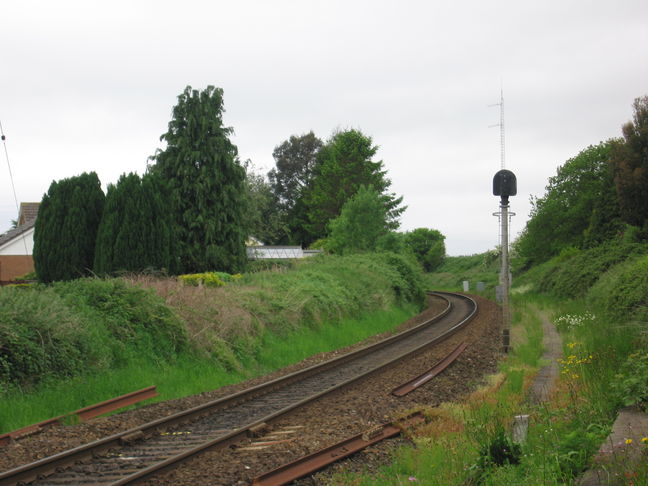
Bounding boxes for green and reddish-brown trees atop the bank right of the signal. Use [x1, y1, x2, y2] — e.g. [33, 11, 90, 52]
[513, 96, 648, 269]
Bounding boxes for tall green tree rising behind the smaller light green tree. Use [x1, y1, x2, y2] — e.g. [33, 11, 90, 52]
[304, 129, 406, 239]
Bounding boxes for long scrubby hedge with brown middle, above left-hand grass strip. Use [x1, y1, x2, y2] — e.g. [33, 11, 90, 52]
[0, 253, 425, 385]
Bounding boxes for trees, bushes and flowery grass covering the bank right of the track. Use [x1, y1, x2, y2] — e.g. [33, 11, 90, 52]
[340, 97, 648, 486]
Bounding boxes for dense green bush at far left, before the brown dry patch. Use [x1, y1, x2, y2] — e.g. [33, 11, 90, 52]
[0, 279, 187, 385]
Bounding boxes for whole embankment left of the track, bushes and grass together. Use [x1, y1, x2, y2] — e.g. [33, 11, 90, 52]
[0, 255, 423, 433]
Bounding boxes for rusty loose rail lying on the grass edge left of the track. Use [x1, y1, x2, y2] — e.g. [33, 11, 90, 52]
[0, 385, 157, 446]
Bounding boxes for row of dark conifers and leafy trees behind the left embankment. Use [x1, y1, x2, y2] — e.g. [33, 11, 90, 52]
[34, 86, 445, 282]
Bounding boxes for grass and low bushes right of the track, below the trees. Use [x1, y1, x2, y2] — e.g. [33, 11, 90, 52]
[334, 242, 648, 486]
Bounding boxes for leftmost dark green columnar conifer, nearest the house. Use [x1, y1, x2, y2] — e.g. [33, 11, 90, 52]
[34, 172, 105, 282]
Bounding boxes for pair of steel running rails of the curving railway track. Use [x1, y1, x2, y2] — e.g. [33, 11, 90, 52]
[0, 293, 476, 486]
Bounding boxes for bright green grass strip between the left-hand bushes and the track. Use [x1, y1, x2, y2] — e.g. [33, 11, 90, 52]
[0, 305, 418, 433]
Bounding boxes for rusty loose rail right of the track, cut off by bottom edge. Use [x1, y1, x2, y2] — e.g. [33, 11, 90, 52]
[252, 412, 425, 486]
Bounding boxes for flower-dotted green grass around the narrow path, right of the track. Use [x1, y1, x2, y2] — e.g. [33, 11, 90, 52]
[332, 294, 648, 486]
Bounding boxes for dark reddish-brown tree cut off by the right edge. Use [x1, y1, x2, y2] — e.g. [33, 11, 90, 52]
[611, 96, 648, 230]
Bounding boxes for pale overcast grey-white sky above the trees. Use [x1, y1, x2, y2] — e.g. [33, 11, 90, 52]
[0, 0, 648, 255]
